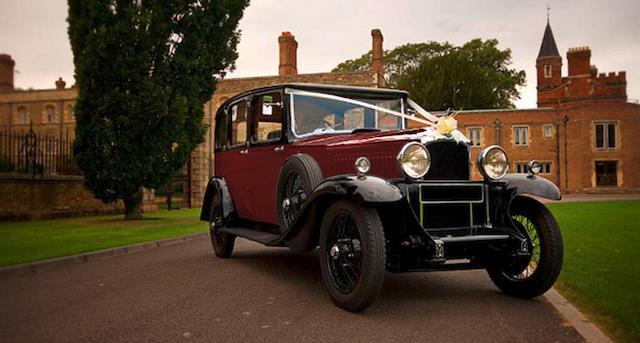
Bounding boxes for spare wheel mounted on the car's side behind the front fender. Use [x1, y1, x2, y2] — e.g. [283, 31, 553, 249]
[276, 154, 322, 230]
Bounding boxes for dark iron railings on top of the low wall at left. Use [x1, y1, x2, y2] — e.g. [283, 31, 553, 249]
[0, 127, 81, 177]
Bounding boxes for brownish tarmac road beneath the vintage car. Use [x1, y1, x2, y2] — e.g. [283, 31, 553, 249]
[0, 239, 583, 342]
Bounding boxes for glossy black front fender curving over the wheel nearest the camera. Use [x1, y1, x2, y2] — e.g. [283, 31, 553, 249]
[273, 175, 403, 252]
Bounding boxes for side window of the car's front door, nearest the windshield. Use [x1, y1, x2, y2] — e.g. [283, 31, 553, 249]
[251, 92, 283, 143]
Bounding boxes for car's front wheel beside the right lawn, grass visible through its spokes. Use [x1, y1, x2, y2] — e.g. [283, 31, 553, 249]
[487, 196, 564, 299]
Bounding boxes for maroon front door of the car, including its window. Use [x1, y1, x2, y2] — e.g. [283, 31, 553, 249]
[249, 91, 289, 225]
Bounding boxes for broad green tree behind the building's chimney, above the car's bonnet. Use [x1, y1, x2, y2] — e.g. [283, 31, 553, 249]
[334, 39, 526, 110]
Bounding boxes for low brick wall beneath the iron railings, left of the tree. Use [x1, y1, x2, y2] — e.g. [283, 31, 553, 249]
[0, 174, 124, 221]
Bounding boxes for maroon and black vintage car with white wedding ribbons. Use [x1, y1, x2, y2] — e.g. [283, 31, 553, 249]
[200, 84, 563, 311]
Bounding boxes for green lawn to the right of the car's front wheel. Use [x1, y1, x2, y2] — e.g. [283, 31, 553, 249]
[549, 201, 640, 342]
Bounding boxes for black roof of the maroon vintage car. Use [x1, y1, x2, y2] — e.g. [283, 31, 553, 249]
[220, 83, 409, 108]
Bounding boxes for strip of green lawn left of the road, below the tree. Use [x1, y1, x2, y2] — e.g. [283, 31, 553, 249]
[0, 209, 207, 266]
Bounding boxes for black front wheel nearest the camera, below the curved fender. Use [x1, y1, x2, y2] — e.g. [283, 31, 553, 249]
[319, 200, 386, 312]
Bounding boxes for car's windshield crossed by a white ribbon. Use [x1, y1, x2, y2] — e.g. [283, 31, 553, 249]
[291, 93, 405, 137]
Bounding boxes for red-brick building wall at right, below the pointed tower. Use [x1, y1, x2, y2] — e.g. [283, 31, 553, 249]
[457, 102, 640, 192]
